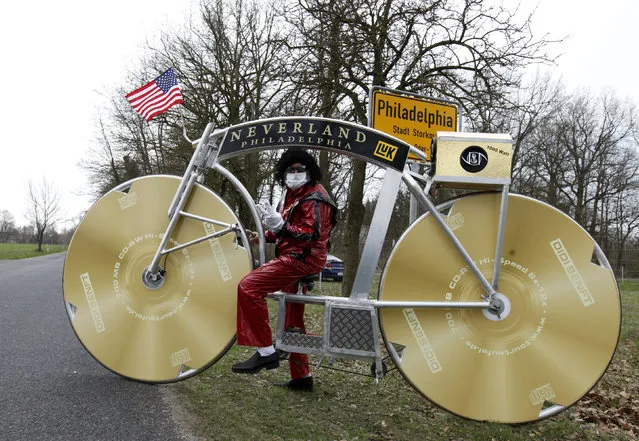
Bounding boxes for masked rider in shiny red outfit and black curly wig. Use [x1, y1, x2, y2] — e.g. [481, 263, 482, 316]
[232, 149, 337, 391]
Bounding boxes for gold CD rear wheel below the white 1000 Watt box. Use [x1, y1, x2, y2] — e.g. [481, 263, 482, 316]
[379, 193, 621, 423]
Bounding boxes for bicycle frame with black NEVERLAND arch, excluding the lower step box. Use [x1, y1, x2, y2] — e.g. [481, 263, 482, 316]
[145, 117, 508, 309]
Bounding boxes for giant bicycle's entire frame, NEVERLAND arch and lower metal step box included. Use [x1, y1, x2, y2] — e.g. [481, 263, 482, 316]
[107, 117, 584, 418]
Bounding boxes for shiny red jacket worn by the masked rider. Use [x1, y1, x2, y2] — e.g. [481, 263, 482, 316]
[266, 184, 337, 272]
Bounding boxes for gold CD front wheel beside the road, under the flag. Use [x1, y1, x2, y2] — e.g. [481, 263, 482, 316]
[63, 176, 251, 382]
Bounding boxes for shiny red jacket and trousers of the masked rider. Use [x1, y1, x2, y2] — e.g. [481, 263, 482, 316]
[237, 184, 334, 378]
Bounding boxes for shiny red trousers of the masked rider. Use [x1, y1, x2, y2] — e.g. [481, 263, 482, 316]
[237, 255, 322, 379]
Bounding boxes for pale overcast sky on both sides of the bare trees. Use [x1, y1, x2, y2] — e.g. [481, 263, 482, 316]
[0, 0, 639, 226]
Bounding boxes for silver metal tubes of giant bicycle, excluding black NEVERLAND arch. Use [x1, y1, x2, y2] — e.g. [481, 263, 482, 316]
[148, 118, 508, 320]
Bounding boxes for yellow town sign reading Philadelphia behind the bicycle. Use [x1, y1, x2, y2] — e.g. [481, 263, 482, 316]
[371, 90, 458, 161]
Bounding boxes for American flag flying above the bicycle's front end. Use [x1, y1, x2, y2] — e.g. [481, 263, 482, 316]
[126, 67, 182, 121]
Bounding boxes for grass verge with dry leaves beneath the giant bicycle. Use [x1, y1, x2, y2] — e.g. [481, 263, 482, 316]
[171, 282, 639, 441]
